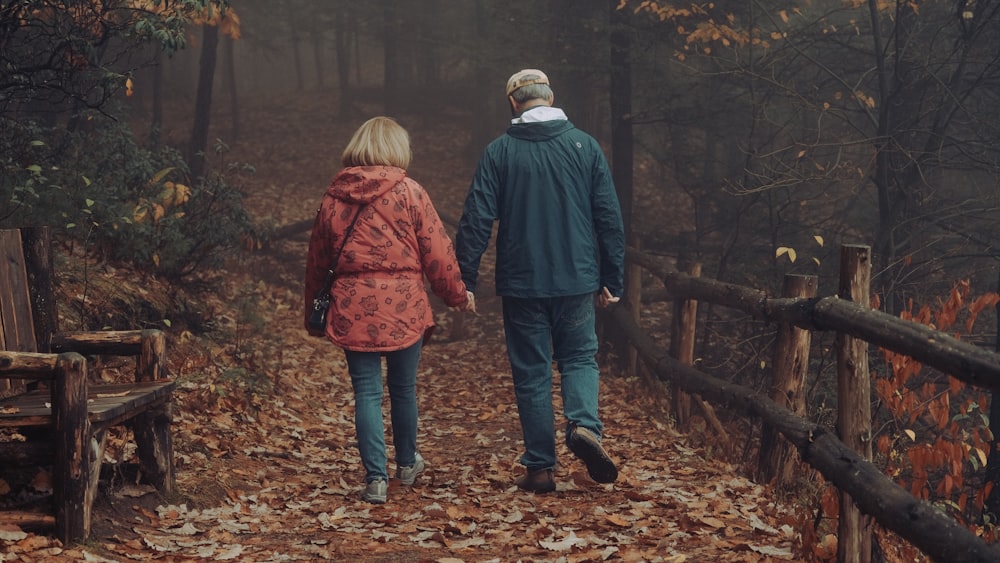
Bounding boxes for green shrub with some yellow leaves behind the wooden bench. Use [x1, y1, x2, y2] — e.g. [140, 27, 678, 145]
[0, 112, 254, 280]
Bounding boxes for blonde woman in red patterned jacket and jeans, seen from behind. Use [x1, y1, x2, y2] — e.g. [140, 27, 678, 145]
[305, 117, 475, 503]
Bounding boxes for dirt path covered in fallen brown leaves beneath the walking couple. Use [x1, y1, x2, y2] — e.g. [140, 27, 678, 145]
[102, 278, 795, 561]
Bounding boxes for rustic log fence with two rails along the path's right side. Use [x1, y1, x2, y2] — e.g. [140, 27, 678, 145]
[609, 245, 1000, 563]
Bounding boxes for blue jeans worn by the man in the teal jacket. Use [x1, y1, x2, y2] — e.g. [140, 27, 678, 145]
[503, 293, 603, 471]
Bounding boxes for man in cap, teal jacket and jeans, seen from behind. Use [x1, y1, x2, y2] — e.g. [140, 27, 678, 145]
[455, 69, 625, 492]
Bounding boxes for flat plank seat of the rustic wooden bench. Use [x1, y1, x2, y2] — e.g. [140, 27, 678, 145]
[0, 381, 177, 427]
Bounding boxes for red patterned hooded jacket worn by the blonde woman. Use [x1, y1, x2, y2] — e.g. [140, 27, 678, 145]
[305, 166, 466, 352]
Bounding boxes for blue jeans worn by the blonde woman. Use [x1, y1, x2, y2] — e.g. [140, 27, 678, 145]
[344, 342, 422, 482]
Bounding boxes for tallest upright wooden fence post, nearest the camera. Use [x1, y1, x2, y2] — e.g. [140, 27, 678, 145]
[836, 245, 872, 563]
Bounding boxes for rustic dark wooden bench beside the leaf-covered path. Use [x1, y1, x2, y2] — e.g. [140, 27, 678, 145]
[0, 227, 175, 543]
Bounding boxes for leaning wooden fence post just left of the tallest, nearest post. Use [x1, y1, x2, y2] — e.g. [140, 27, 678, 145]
[757, 274, 817, 485]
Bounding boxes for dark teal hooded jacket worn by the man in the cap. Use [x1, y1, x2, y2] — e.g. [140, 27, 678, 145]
[455, 120, 625, 298]
